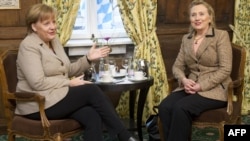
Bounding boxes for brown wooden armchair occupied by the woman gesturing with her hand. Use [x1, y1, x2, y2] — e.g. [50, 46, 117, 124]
[0, 48, 83, 141]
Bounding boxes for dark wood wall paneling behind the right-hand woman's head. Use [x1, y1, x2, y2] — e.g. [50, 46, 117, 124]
[157, 0, 234, 24]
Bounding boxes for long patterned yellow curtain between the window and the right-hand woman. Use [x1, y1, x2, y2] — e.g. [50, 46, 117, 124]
[116, 0, 168, 121]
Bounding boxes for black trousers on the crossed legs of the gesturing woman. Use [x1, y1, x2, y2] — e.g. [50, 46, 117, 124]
[26, 84, 126, 141]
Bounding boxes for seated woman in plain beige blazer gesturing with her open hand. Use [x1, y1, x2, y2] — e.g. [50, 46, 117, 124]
[15, 4, 135, 141]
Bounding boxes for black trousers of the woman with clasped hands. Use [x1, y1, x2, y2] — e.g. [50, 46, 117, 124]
[159, 90, 227, 141]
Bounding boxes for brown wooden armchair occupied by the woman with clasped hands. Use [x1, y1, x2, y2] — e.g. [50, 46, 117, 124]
[158, 44, 246, 141]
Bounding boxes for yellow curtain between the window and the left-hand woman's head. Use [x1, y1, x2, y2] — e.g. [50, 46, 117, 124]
[42, 0, 81, 46]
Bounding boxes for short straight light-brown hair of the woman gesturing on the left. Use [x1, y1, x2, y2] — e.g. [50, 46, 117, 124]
[26, 3, 56, 33]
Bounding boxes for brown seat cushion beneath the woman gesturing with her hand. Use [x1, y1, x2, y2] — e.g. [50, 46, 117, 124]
[12, 116, 82, 135]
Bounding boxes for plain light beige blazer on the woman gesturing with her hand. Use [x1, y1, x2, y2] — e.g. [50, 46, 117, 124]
[15, 33, 90, 115]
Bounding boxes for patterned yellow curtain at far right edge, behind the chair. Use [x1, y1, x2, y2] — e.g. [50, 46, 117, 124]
[231, 0, 250, 115]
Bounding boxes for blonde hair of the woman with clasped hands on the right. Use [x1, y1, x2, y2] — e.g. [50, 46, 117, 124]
[188, 0, 216, 32]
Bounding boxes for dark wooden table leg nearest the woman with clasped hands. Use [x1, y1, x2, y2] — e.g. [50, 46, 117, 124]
[137, 87, 149, 141]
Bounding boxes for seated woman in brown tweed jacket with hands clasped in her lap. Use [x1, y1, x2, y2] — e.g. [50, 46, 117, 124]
[159, 0, 232, 141]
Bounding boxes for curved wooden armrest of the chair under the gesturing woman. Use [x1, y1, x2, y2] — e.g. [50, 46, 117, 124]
[14, 92, 50, 128]
